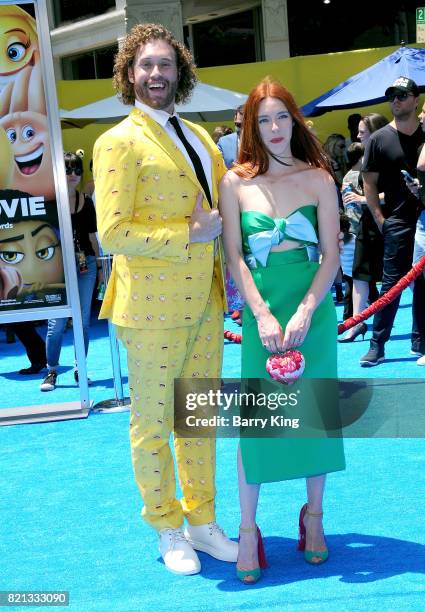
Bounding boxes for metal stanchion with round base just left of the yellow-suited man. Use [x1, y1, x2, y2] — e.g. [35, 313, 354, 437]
[92, 254, 130, 412]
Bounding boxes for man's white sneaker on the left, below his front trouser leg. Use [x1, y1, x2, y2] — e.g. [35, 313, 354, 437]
[159, 529, 201, 576]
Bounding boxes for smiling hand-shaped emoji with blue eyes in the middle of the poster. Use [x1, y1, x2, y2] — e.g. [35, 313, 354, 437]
[0, 111, 55, 200]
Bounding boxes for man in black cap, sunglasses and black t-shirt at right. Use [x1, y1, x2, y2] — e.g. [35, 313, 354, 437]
[360, 76, 425, 367]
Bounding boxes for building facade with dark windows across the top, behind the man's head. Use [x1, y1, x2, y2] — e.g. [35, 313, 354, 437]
[47, 0, 416, 80]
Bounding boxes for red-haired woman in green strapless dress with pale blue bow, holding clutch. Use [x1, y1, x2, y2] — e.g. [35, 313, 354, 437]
[220, 79, 345, 584]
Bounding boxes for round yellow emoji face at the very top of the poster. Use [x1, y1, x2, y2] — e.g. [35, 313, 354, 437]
[0, 5, 38, 93]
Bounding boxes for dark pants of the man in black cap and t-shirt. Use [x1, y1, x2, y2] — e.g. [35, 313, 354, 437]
[371, 220, 425, 346]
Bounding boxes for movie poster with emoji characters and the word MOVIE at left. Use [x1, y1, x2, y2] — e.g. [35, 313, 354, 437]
[0, 3, 66, 311]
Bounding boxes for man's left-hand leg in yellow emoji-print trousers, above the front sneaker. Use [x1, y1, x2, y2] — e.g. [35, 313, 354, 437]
[117, 327, 190, 531]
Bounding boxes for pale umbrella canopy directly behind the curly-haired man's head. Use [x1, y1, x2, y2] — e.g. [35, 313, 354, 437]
[60, 83, 248, 125]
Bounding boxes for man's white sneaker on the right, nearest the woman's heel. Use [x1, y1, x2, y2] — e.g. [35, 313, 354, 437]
[184, 522, 238, 563]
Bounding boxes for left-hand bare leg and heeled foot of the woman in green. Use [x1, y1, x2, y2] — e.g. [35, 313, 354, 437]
[237, 447, 260, 582]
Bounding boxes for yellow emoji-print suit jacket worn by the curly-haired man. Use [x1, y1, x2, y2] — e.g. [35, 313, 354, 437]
[93, 109, 226, 329]
